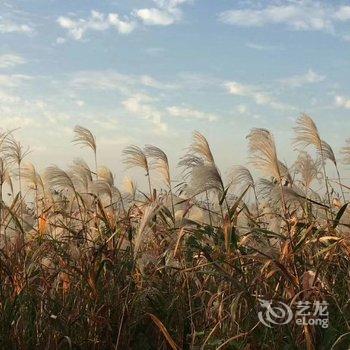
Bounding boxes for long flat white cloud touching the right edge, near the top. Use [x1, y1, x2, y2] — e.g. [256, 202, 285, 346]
[219, 0, 350, 31]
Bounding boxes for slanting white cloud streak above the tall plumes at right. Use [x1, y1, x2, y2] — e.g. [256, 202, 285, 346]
[224, 81, 293, 110]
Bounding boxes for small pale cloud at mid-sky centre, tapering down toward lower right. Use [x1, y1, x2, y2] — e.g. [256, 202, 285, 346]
[122, 94, 168, 134]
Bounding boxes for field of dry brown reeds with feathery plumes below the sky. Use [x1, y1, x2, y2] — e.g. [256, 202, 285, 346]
[0, 114, 350, 350]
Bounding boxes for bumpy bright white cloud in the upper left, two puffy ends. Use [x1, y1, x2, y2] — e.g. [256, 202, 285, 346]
[57, 11, 135, 40]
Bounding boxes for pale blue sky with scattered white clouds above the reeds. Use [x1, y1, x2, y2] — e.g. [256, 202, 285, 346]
[0, 0, 350, 180]
